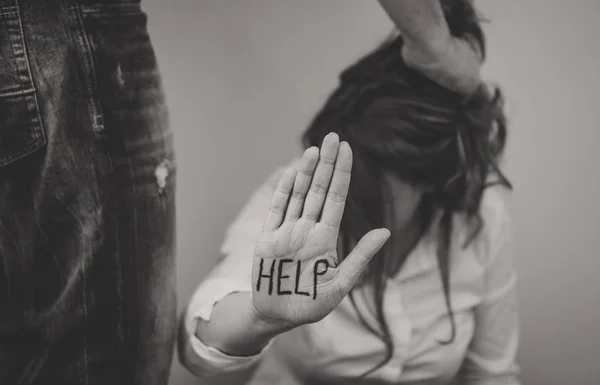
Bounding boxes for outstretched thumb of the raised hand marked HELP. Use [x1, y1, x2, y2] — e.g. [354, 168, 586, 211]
[338, 229, 390, 294]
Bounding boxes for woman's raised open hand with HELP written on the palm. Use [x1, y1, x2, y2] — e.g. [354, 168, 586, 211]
[252, 134, 389, 327]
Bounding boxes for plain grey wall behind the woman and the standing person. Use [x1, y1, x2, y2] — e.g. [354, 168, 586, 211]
[143, 0, 600, 385]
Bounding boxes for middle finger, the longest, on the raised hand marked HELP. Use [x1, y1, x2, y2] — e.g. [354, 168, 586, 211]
[302, 133, 340, 221]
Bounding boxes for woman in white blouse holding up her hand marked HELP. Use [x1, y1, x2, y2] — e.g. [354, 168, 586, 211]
[180, 1, 520, 385]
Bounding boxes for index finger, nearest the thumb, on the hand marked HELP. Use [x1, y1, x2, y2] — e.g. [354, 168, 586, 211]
[321, 142, 352, 228]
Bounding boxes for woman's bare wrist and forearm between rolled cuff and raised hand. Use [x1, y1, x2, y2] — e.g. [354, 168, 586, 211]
[196, 293, 285, 356]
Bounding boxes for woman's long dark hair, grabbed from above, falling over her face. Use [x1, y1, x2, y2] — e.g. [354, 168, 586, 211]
[303, 0, 511, 375]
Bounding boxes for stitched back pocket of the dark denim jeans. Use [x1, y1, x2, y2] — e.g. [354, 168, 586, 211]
[0, 6, 47, 167]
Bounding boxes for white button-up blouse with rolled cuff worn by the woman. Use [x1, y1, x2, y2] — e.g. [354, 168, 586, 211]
[180, 160, 520, 385]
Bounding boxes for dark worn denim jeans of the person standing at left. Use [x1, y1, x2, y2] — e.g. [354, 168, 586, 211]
[0, 0, 176, 385]
